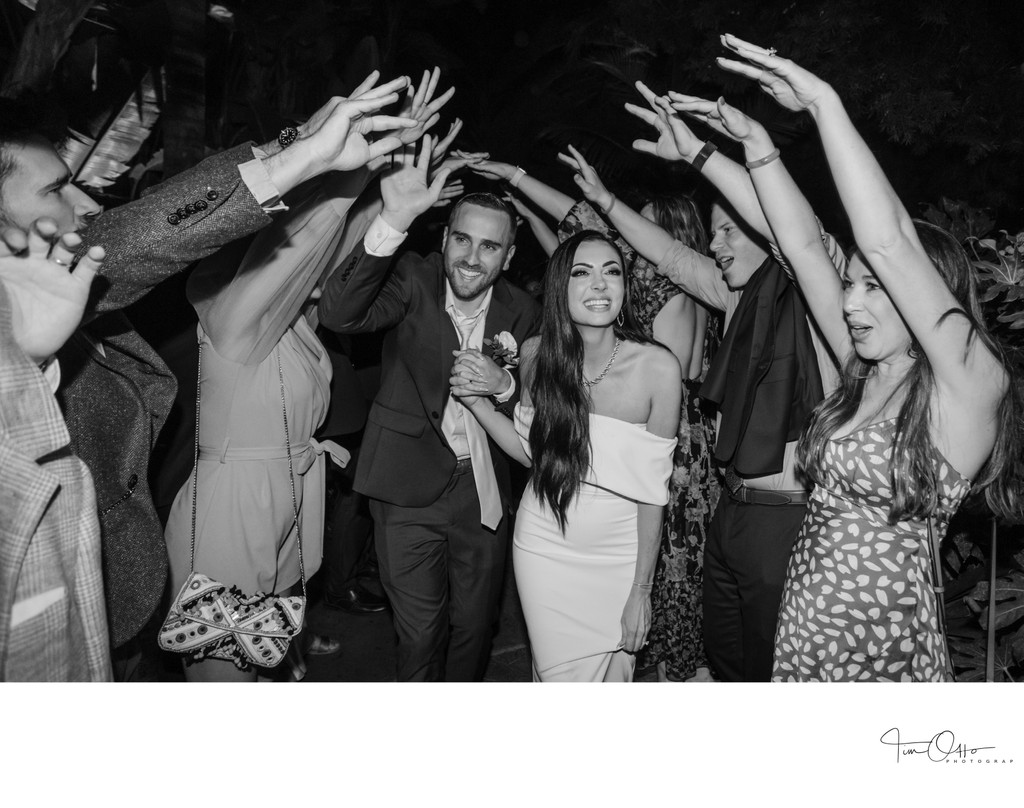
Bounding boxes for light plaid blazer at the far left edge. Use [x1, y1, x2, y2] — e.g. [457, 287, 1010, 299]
[0, 282, 111, 682]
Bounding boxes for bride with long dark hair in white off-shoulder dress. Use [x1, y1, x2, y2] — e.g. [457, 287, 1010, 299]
[452, 231, 681, 681]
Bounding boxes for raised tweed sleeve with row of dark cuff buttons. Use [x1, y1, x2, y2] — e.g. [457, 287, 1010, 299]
[79, 144, 270, 318]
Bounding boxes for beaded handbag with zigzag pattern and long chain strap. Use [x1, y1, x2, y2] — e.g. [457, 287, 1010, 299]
[160, 340, 306, 671]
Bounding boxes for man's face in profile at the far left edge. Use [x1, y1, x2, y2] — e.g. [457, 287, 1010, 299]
[0, 138, 102, 235]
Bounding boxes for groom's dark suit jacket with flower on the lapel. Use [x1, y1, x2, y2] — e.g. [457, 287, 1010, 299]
[318, 246, 541, 507]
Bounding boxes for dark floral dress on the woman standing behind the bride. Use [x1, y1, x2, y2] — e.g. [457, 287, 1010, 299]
[558, 201, 721, 679]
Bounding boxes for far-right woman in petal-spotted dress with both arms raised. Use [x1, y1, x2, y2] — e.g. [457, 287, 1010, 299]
[667, 35, 1024, 681]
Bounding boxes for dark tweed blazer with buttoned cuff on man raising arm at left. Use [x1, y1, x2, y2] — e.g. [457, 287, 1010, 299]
[57, 144, 270, 647]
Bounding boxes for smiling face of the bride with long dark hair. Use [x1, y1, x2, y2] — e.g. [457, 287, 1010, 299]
[567, 241, 626, 328]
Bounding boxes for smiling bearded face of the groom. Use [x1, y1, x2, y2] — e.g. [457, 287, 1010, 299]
[443, 205, 515, 303]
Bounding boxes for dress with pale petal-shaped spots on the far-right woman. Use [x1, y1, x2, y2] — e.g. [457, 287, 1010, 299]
[772, 419, 971, 682]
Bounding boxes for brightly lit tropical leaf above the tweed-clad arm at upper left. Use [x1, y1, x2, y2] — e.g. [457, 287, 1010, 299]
[62, 72, 160, 188]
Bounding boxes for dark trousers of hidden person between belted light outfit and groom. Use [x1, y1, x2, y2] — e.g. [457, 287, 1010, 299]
[319, 432, 374, 596]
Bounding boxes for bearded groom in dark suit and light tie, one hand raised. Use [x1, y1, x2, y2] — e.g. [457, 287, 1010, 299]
[318, 138, 540, 681]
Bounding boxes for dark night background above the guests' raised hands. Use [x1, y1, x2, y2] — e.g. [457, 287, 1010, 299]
[0, 0, 1024, 261]
